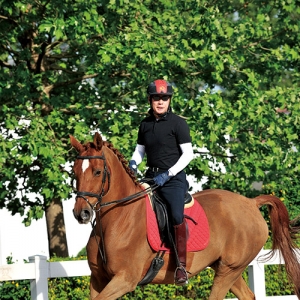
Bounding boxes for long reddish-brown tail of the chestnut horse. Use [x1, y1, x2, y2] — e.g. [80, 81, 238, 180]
[255, 195, 300, 299]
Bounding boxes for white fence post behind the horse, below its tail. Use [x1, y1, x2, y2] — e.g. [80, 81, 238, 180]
[248, 260, 267, 300]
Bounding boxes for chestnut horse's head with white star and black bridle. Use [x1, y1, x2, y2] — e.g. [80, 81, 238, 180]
[70, 133, 110, 224]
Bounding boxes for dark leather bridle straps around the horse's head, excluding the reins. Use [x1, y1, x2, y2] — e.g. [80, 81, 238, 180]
[76, 153, 110, 211]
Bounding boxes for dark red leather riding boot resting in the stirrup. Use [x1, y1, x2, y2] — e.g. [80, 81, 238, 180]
[174, 221, 188, 285]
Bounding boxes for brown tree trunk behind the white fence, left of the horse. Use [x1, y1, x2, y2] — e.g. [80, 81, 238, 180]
[45, 198, 69, 257]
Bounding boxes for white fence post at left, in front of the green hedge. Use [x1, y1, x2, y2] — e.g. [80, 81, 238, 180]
[29, 255, 49, 300]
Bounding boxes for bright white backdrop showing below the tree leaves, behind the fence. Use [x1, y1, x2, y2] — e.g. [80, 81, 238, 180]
[0, 176, 202, 265]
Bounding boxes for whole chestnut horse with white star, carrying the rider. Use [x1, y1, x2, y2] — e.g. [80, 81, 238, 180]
[70, 133, 300, 300]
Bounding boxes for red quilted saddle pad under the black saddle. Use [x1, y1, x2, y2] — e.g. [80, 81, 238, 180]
[146, 196, 209, 253]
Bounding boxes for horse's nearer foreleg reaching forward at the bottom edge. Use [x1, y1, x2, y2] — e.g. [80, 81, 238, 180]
[92, 272, 138, 300]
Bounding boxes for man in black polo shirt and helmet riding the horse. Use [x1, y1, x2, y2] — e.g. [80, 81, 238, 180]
[129, 79, 193, 285]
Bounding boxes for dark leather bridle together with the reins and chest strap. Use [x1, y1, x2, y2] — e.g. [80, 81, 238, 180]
[76, 153, 159, 264]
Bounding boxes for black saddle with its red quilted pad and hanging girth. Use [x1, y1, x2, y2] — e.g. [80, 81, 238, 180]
[139, 184, 210, 285]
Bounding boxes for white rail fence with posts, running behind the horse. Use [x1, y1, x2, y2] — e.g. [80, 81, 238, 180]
[0, 250, 297, 300]
